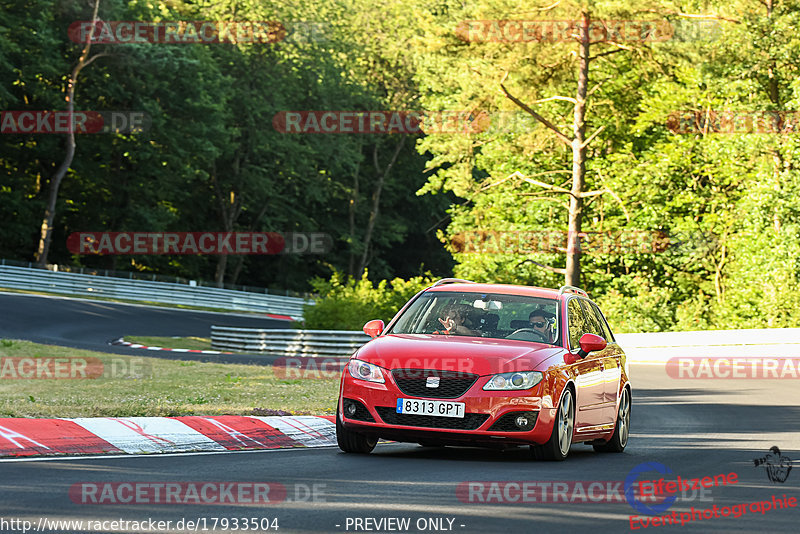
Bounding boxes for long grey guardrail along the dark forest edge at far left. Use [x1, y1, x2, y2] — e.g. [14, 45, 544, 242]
[0, 265, 313, 320]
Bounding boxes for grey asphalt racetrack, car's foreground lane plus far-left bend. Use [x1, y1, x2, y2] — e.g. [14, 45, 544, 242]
[0, 296, 800, 534]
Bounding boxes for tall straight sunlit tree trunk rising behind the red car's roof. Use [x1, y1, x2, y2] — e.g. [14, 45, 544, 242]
[564, 11, 589, 287]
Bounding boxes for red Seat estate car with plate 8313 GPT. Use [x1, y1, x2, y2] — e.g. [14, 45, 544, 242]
[336, 279, 631, 460]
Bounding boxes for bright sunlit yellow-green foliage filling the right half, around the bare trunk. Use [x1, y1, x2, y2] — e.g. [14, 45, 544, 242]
[415, 0, 800, 332]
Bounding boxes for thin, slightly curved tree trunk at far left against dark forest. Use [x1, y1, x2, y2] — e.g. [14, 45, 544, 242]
[34, 0, 107, 267]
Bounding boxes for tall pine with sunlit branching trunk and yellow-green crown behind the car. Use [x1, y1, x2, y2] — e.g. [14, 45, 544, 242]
[412, 1, 708, 285]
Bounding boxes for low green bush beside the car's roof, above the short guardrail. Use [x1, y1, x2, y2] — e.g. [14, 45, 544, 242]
[303, 272, 434, 330]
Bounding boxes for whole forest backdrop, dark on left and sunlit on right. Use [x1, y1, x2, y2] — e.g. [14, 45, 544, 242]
[0, 0, 800, 331]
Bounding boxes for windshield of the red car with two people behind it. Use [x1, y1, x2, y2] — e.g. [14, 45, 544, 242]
[389, 291, 560, 345]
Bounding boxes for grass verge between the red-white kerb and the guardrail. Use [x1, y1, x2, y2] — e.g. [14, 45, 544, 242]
[0, 338, 339, 417]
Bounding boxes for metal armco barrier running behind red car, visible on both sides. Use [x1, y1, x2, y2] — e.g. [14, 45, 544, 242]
[211, 326, 800, 363]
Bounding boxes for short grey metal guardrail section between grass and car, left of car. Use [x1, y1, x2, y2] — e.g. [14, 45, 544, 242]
[211, 326, 370, 358]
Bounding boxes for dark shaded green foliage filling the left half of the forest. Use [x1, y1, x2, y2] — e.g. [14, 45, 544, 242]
[0, 0, 452, 291]
